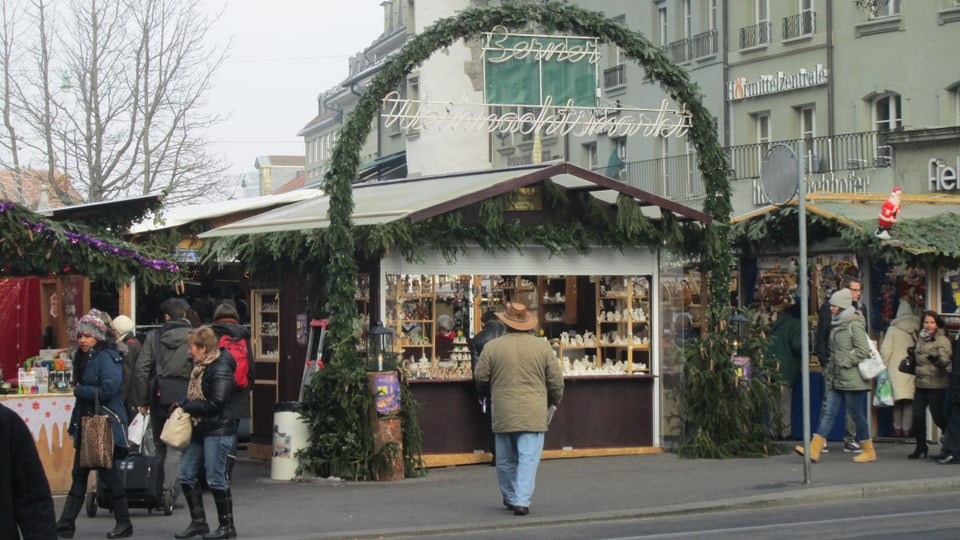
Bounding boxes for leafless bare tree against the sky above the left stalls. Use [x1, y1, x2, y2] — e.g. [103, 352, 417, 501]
[0, 0, 225, 203]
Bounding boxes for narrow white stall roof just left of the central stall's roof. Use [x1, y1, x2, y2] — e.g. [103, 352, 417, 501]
[130, 189, 323, 234]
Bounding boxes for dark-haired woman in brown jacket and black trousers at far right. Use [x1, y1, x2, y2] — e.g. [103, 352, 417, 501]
[907, 310, 952, 459]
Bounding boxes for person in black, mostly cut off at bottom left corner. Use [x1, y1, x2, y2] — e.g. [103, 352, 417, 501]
[0, 398, 57, 540]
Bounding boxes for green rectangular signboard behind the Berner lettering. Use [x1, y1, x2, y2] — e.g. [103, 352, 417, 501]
[483, 27, 600, 107]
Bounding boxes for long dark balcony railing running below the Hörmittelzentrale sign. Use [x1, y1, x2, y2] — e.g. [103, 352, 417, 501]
[594, 131, 894, 200]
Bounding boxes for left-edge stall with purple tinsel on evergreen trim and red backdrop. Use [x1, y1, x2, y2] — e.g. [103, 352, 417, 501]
[0, 197, 179, 492]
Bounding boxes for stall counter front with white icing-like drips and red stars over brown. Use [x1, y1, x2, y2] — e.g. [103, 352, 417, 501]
[0, 393, 74, 494]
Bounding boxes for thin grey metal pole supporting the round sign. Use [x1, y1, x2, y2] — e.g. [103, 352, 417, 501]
[797, 140, 810, 484]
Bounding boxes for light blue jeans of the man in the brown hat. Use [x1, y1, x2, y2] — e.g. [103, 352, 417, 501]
[494, 431, 543, 506]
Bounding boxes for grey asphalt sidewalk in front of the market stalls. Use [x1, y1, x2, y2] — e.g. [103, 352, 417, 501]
[57, 443, 960, 539]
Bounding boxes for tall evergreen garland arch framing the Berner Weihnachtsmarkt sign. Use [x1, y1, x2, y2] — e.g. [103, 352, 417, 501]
[311, 1, 742, 472]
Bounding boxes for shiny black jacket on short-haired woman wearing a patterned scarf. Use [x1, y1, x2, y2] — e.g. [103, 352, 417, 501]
[180, 351, 237, 440]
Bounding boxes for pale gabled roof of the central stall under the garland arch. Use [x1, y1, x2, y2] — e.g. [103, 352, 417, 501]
[200, 161, 710, 238]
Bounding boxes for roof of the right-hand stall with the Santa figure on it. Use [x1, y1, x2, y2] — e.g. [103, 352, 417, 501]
[732, 192, 960, 254]
